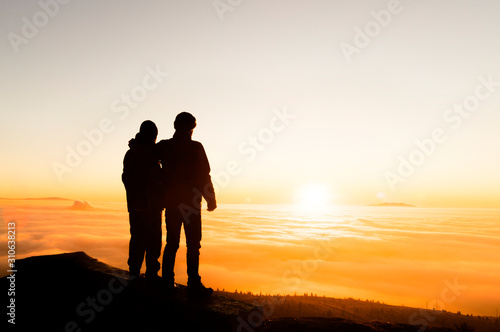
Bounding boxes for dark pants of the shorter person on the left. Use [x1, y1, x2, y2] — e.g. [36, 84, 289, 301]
[128, 210, 162, 275]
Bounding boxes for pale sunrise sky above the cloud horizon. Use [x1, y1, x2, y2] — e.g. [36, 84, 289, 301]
[0, 0, 500, 208]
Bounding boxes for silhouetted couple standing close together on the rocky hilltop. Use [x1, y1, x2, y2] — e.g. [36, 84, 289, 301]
[122, 112, 217, 297]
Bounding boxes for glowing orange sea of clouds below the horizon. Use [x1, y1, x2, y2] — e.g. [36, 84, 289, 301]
[0, 198, 500, 315]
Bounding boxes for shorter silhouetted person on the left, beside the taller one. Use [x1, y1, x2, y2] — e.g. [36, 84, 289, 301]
[122, 120, 163, 279]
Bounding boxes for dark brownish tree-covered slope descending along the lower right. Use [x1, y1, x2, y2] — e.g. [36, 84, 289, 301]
[224, 291, 500, 332]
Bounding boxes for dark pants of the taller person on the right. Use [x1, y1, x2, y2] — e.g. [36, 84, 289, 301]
[162, 202, 201, 284]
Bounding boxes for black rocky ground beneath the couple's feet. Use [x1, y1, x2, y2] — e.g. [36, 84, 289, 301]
[0, 252, 492, 332]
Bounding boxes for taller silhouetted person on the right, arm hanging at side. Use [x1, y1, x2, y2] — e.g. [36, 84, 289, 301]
[157, 112, 217, 297]
